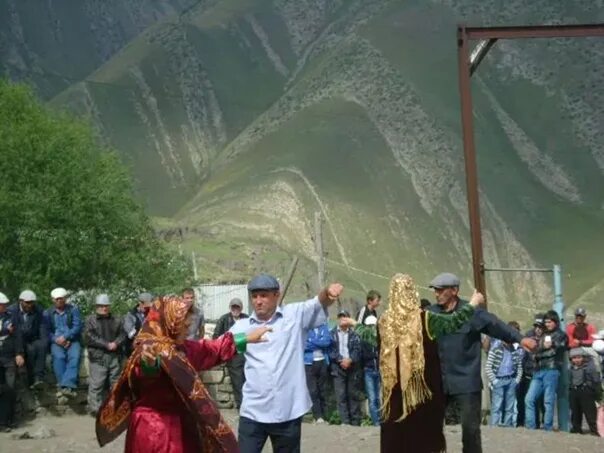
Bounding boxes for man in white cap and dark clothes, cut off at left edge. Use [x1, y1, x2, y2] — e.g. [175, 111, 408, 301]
[0, 293, 25, 432]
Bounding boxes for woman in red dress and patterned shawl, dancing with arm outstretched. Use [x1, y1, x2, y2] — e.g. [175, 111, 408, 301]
[96, 297, 269, 453]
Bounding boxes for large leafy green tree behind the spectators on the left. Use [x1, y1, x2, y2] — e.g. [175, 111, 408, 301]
[0, 80, 190, 297]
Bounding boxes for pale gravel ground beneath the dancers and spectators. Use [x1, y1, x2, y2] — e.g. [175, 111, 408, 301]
[0, 411, 604, 453]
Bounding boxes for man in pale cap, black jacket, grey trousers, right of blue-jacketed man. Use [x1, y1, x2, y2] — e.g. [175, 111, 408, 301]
[84, 294, 126, 416]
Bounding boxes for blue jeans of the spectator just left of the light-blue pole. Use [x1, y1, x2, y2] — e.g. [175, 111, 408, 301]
[524, 370, 560, 431]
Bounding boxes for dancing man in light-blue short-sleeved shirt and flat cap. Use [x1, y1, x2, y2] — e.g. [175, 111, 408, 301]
[231, 274, 343, 453]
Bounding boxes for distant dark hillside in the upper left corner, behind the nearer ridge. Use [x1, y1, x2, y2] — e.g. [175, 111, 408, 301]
[0, 0, 198, 98]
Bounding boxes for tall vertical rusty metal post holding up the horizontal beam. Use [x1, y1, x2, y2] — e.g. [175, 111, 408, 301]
[457, 26, 486, 299]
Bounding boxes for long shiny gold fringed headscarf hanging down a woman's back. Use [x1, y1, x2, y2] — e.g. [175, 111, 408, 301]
[379, 274, 432, 421]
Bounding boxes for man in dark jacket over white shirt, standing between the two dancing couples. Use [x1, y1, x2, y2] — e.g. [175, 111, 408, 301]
[329, 310, 361, 426]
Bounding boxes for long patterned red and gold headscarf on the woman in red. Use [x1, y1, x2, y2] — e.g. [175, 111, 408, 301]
[96, 297, 239, 453]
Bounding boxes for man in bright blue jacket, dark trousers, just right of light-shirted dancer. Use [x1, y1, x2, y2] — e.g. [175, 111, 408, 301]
[304, 322, 331, 423]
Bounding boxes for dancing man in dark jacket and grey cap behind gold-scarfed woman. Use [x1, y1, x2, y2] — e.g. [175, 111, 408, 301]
[429, 273, 536, 453]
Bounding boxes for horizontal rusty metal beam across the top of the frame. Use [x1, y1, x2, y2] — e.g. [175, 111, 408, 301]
[460, 24, 604, 39]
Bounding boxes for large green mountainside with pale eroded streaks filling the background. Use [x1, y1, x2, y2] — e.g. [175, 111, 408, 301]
[3, 0, 604, 324]
